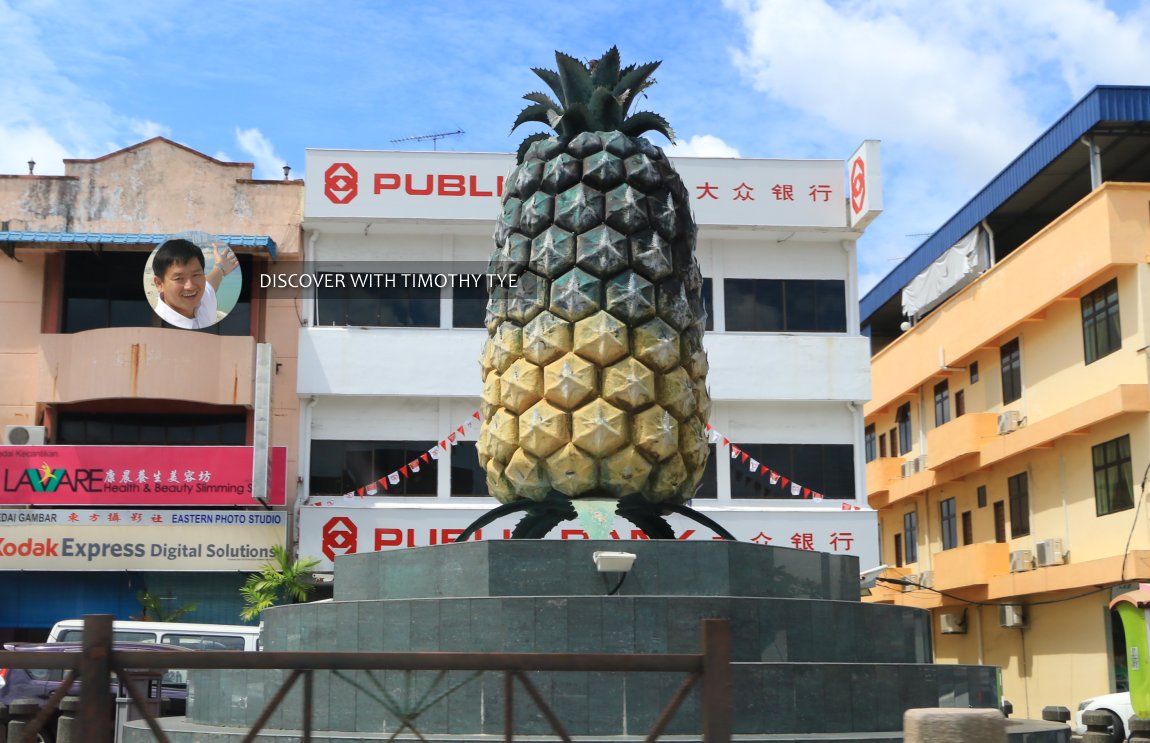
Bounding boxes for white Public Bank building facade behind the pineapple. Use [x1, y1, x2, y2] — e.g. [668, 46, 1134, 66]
[297, 148, 881, 569]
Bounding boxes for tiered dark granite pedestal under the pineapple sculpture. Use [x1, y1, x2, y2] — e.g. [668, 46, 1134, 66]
[124, 541, 1070, 743]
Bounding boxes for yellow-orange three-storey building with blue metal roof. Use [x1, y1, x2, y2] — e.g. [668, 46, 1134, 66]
[860, 87, 1150, 718]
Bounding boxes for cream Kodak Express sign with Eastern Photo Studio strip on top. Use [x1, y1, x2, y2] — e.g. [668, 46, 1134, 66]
[0, 508, 288, 570]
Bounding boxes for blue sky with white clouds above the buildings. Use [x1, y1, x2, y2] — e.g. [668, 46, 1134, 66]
[0, 0, 1150, 291]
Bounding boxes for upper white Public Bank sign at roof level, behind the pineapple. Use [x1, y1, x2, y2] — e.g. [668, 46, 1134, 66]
[304, 150, 851, 229]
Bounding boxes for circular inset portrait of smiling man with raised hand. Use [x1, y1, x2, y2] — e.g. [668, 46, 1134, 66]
[144, 232, 244, 330]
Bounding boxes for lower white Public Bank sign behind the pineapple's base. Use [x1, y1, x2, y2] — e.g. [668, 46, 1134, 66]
[299, 497, 879, 570]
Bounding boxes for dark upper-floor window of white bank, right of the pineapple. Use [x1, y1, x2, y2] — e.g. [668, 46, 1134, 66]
[723, 278, 846, 332]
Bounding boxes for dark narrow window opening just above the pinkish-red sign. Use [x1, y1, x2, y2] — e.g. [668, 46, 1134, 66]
[55, 412, 247, 446]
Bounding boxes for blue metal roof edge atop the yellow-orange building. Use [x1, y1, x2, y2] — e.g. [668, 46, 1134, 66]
[859, 85, 1150, 325]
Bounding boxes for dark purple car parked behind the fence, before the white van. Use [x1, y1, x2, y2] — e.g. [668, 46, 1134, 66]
[0, 642, 194, 743]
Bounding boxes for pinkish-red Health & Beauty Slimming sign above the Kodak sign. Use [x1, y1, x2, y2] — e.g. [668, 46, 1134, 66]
[0, 446, 286, 506]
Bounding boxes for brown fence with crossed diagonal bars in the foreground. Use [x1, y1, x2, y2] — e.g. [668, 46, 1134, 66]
[0, 614, 733, 743]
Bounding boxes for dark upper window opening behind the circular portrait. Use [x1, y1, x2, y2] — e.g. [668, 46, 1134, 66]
[61, 251, 253, 336]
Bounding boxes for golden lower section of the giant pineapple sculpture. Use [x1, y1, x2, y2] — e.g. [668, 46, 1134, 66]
[478, 313, 711, 503]
